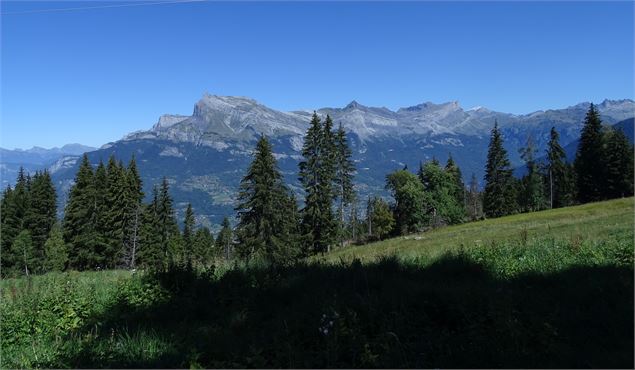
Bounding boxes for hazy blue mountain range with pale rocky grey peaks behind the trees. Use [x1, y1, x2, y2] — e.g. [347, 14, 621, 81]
[1, 94, 635, 228]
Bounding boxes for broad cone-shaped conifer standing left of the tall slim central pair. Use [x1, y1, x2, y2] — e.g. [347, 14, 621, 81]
[236, 136, 297, 263]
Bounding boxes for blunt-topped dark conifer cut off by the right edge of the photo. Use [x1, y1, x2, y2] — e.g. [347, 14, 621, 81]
[603, 129, 633, 198]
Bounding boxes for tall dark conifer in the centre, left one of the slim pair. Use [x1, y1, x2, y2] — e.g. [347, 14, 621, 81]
[299, 113, 336, 254]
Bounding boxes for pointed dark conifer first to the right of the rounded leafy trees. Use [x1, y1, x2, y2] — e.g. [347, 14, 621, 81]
[483, 122, 518, 217]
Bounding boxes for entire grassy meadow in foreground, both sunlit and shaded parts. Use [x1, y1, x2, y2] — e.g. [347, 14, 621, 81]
[0, 198, 634, 368]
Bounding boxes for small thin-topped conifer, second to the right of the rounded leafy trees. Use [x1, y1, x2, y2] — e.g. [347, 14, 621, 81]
[518, 136, 545, 212]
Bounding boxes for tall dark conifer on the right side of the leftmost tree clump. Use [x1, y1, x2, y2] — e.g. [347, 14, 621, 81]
[24, 171, 57, 271]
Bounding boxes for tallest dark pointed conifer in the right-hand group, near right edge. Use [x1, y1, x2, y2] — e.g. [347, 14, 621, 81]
[574, 104, 605, 203]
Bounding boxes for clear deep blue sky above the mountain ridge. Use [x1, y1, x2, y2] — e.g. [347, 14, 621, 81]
[0, 0, 634, 148]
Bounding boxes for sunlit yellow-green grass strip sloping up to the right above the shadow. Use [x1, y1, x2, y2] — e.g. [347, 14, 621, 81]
[326, 198, 634, 262]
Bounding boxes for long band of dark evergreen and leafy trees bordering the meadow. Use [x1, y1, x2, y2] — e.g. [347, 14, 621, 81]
[0, 105, 633, 276]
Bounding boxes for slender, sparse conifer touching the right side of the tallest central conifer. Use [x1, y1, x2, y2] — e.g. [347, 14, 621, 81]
[335, 123, 355, 246]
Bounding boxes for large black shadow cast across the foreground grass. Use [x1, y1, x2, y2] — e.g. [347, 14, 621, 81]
[61, 257, 633, 368]
